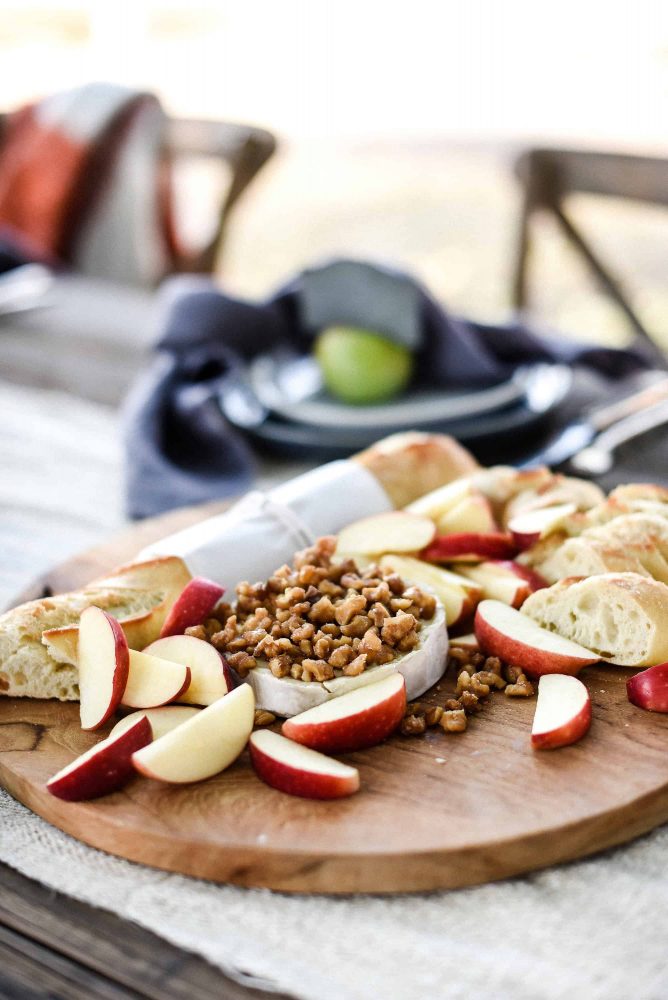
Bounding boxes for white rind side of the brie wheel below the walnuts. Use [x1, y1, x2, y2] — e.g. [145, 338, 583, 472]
[245, 602, 448, 718]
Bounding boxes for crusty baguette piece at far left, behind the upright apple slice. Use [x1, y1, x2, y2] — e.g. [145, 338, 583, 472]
[0, 556, 190, 701]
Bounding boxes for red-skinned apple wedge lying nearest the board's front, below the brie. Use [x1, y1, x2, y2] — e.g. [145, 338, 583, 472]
[250, 729, 360, 799]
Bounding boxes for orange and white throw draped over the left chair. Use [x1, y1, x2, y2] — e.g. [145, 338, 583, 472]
[0, 83, 178, 284]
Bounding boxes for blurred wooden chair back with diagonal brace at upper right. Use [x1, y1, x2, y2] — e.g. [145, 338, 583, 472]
[513, 143, 668, 351]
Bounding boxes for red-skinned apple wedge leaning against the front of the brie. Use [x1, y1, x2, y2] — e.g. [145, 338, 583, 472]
[281, 674, 406, 753]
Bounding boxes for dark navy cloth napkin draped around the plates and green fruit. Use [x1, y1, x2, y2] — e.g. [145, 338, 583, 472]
[125, 260, 650, 517]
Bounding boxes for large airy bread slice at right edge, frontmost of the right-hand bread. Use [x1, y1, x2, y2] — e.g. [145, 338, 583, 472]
[522, 573, 668, 667]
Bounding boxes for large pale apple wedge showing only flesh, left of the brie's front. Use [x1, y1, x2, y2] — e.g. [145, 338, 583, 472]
[132, 684, 255, 784]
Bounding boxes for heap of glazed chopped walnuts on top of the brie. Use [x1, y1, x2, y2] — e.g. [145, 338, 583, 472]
[186, 536, 437, 682]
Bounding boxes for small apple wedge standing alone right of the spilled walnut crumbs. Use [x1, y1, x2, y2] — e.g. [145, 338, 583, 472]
[531, 674, 591, 750]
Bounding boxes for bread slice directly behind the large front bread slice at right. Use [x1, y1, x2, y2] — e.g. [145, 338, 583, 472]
[532, 537, 651, 583]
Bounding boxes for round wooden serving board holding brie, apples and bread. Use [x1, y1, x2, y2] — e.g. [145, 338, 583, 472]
[0, 505, 668, 893]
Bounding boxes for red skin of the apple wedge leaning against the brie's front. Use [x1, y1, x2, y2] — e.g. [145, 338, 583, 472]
[281, 684, 406, 753]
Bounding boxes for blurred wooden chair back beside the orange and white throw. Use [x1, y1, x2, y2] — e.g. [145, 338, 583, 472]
[0, 114, 276, 274]
